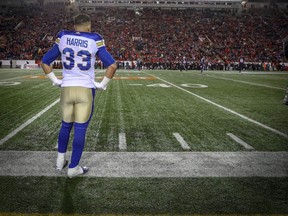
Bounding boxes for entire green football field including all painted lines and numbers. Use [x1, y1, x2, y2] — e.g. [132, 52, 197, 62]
[0, 69, 288, 216]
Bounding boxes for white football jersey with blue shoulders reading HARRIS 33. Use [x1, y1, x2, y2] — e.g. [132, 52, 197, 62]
[55, 31, 105, 88]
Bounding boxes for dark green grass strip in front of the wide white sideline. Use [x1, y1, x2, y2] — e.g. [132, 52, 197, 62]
[0, 177, 288, 215]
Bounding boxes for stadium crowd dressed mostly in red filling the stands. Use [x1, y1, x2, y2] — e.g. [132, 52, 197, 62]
[0, 8, 288, 70]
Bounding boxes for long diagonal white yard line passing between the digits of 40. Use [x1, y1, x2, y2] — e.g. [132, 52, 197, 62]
[143, 72, 288, 139]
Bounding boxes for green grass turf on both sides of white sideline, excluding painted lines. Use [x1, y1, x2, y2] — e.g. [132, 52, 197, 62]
[0, 70, 288, 215]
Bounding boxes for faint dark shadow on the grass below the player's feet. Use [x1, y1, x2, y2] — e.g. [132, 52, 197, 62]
[60, 178, 83, 214]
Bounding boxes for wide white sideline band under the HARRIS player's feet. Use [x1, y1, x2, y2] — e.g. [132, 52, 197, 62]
[0, 151, 288, 178]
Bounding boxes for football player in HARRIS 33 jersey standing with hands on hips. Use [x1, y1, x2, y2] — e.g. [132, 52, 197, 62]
[41, 14, 117, 178]
